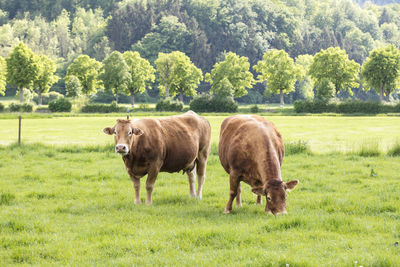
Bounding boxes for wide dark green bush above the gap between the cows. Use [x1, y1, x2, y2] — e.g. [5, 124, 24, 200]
[189, 94, 238, 112]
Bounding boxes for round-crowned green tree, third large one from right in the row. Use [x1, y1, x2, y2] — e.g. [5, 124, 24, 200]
[253, 49, 302, 107]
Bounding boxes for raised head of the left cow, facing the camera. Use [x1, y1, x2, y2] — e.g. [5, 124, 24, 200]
[103, 120, 144, 155]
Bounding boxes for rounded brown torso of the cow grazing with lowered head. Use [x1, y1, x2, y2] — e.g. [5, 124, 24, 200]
[218, 115, 284, 184]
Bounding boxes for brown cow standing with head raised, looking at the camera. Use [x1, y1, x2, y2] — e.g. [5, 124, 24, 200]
[103, 111, 211, 204]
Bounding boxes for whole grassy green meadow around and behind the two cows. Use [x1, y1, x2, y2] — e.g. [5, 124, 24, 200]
[0, 115, 400, 266]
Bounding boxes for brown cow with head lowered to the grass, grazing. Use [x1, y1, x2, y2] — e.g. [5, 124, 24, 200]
[218, 115, 298, 215]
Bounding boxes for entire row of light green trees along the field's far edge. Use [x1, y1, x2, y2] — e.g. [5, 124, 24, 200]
[0, 42, 400, 106]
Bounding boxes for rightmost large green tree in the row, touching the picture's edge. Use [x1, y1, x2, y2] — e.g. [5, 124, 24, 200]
[361, 45, 400, 101]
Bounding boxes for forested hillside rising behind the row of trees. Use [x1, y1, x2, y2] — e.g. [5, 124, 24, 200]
[0, 0, 400, 103]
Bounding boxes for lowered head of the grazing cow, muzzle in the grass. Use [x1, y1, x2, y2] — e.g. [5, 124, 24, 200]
[252, 179, 299, 215]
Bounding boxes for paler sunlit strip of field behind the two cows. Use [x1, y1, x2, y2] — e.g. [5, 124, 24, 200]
[0, 113, 400, 153]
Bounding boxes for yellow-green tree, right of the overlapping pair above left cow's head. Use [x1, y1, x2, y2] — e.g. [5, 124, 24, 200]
[123, 51, 155, 107]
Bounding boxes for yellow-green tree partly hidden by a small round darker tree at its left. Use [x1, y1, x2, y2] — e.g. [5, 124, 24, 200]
[66, 55, 101, 96]
